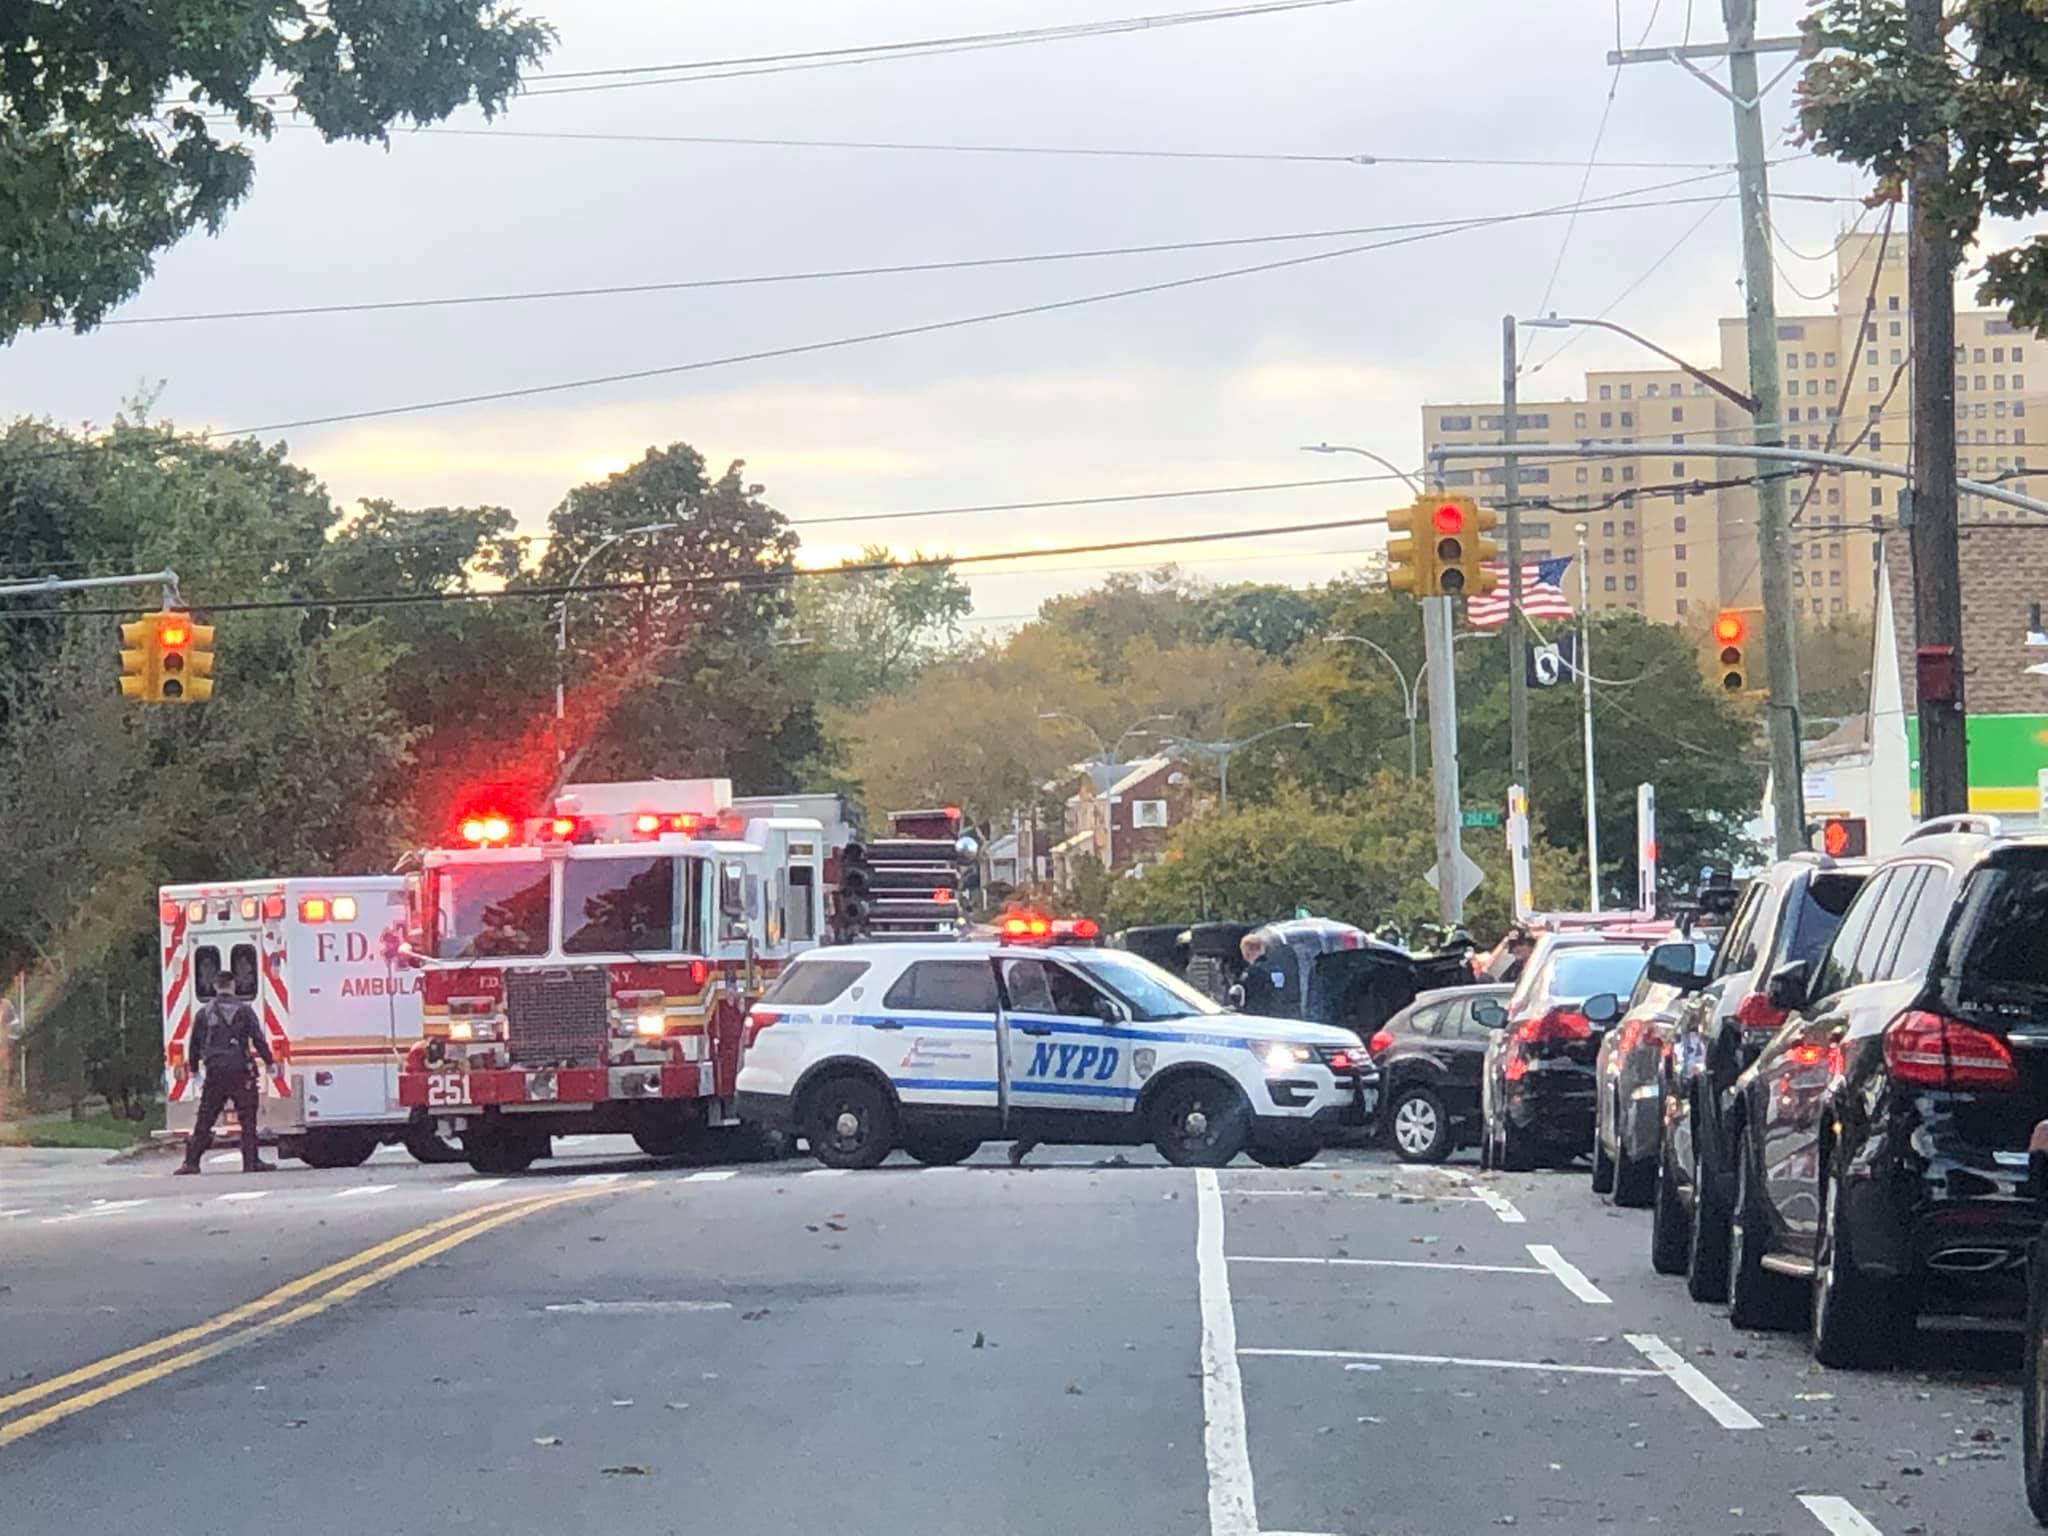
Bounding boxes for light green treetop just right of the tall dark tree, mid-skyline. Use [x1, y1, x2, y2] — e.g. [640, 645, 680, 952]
[791, 545, 975, 709]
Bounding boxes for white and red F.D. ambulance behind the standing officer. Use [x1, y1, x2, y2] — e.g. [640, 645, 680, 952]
[158, 874, 459, 1167]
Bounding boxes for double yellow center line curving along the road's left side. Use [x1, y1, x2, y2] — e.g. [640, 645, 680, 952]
[0, 1180, 649, 1446]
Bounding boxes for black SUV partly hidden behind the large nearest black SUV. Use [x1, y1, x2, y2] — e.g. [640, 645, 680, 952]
[1651, 854, 1870, 1300]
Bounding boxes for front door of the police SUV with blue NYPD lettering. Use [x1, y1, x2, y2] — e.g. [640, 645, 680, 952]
[997, 956, 1137, 1128]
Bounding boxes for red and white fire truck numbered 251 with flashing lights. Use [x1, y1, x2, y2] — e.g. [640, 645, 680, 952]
[399, 778, 975, 1174]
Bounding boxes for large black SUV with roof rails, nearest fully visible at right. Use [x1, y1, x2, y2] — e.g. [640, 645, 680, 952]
[1729, 817, 2048, 1366]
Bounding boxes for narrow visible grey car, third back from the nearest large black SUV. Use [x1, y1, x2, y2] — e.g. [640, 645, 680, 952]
[1593, 938, 1714, 1206]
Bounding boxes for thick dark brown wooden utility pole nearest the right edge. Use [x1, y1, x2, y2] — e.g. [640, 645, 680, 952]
[1907, 0, 1970, 817]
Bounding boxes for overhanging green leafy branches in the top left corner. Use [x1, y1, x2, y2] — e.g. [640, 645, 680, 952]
[0, 0, 553, 342]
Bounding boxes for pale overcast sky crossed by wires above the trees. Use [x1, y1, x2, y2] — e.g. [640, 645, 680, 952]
[0, 0, 1860, 623]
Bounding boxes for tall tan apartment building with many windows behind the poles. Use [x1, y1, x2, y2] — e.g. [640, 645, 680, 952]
[1423, 229, 2023, 625]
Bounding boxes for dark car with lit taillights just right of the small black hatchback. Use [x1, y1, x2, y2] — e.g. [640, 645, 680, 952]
[1479, 934, 1649, 1171]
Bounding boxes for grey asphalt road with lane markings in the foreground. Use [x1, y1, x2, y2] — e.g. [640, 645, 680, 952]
[0, 1141, 2030, 1536]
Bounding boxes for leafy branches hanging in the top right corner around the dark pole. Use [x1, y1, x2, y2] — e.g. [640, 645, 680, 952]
[1798, 0, 2048, 334]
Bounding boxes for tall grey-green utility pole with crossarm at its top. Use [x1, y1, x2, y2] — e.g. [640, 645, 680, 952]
[1608, 0, 1810, 858]
